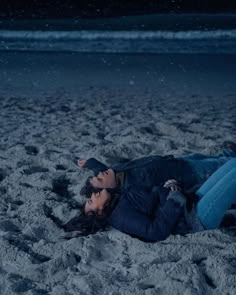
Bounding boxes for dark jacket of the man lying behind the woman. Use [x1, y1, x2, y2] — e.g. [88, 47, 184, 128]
[86, 155, 197, 190]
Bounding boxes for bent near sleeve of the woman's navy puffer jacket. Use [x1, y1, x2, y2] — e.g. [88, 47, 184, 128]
[112, 191, 186, 242]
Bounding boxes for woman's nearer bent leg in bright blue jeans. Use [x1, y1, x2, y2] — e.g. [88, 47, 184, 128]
[196, 168, 236, 229]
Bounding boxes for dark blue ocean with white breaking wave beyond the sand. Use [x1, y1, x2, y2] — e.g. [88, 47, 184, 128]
[0, 16, 236, 54]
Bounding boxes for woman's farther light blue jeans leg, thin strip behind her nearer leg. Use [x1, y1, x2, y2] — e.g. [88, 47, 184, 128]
[196, 158, 236, 199]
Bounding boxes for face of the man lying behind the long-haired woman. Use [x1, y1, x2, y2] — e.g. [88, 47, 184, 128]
[90, 168, 116, 188]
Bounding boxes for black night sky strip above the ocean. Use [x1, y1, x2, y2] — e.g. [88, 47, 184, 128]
[0, 0, 236, 19]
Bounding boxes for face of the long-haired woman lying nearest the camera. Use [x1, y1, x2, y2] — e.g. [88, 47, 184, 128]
[84, 189, 111, 213]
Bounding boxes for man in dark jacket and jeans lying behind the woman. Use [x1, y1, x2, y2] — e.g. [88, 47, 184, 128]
[78, 142, 236, 194]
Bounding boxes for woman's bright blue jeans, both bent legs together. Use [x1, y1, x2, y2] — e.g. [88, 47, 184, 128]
[196, 158, 236, 229]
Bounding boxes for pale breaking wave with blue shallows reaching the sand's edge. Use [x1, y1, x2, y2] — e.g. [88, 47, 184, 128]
[0, 29, 236, 54]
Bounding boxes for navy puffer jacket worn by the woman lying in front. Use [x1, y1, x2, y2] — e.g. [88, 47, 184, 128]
[109, 186, 186, 242]
